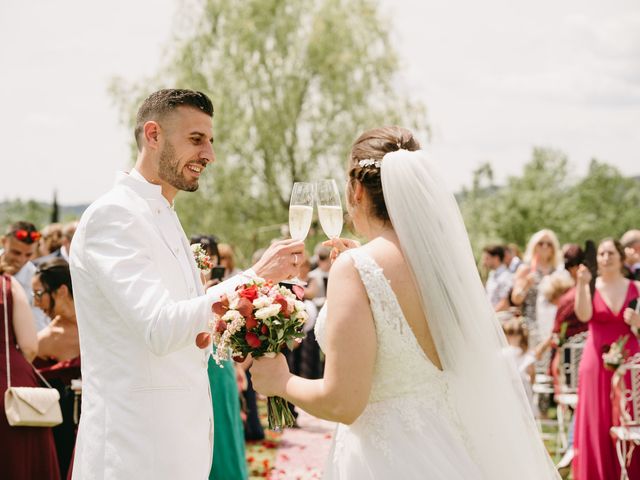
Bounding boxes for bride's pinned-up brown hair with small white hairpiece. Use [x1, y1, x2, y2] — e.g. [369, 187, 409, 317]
[347, 125, 420, 222]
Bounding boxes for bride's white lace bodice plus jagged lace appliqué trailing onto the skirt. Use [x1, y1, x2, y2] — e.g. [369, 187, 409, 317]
[315, 248, 464, 460]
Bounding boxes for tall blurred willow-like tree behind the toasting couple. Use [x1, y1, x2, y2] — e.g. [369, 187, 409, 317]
[112, 0, 427, 262]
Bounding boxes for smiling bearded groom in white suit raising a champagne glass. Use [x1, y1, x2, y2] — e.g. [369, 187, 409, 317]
[70, 89, 304, 480]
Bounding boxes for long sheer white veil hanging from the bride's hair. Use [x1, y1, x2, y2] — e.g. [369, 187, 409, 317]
[381, 150, 560, 480]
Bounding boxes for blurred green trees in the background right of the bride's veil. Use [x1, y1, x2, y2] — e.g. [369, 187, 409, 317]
[460, 148, 640, 253]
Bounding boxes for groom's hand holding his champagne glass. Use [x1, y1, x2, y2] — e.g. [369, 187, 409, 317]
[253, 240, 304, 282]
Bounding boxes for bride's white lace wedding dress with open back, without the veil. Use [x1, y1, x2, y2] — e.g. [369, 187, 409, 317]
[315, 248, 482, 480]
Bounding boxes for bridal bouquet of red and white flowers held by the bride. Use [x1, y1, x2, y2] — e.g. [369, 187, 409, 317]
[209, 278, 307, 430]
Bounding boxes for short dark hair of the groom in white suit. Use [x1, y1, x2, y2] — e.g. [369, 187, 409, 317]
[134, 88, 213, 150]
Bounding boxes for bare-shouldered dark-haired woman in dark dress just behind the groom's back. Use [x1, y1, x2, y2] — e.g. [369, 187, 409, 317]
[32, 258, 80, 478]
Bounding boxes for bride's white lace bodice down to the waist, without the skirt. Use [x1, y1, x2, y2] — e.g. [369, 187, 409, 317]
[315, 248, 446, 403]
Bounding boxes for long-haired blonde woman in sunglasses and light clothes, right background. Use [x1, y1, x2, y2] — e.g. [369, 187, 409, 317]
[511, 229, 562, 347]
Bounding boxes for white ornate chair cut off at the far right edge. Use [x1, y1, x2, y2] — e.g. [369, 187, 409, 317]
[610, 353, 640, 480]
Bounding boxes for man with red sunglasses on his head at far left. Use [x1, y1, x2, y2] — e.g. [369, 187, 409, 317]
[0, 222, 49, 331]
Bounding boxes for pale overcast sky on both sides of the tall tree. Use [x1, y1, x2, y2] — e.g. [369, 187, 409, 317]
[0, 0, 640, 205]
